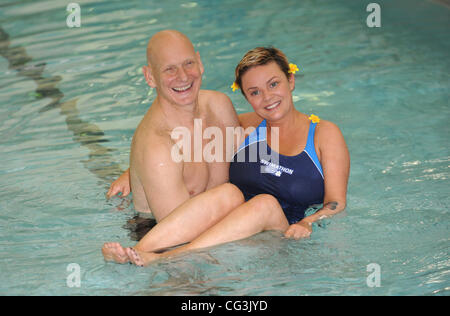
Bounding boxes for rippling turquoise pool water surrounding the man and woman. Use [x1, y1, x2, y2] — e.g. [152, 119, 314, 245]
[0, 0, 450, 295]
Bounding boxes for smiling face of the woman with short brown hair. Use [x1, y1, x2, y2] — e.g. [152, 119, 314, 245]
[241, 62, 295, 122]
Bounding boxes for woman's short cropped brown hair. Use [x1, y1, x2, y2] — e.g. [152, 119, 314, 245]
[234, 47, 289, 96]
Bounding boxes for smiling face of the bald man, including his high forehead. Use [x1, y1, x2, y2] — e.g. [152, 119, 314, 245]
[151, 40, 203, 105]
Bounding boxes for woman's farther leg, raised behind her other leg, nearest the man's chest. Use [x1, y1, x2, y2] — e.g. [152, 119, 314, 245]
[102, 183, 245, 263]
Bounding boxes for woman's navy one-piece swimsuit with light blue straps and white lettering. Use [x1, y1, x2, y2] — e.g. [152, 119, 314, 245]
[230, 120, 324, 224]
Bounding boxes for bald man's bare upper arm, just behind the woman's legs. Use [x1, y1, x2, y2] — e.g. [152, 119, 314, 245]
[136, 143, 190, 222]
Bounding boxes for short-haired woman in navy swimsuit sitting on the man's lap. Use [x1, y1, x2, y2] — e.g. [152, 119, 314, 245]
[104, 47, 350, 266]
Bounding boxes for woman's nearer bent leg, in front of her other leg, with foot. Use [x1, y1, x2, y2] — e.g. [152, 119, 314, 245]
[126, 194, 289, 266]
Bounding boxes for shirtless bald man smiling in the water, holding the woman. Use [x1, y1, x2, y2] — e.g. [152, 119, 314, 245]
[108, 30, 239, 222]
